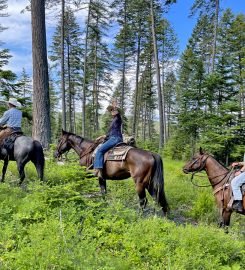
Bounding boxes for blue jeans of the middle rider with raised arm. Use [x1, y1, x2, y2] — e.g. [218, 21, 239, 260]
[94, 136, 122, 169]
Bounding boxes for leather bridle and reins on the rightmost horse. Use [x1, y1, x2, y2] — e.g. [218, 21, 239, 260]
[187, 154, 233, 187]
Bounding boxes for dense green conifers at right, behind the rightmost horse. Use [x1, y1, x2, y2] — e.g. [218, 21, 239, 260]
[166, 9, 244, 163]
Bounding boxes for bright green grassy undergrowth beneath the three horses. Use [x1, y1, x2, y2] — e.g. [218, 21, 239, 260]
[0, 156, 245, 270]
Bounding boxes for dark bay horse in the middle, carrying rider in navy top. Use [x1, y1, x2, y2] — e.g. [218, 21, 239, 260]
[54, 130, 168, 215]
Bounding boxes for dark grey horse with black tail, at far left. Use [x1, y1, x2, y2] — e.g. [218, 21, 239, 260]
[0, 135, 45, 185]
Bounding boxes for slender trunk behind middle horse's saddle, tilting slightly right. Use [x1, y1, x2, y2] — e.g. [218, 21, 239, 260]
[132, 16, 141, 136]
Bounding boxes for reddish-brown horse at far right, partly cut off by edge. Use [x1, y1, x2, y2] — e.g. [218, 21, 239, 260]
[183, 148, 245, 227]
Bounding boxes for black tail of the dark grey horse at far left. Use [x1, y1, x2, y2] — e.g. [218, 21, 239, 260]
[31, 141, 45, 181]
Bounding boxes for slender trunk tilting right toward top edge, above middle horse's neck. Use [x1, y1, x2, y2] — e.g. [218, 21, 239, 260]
[82, 0, 92, 137]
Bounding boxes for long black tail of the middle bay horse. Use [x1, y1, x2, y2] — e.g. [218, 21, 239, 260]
[151, 153, 169, 213]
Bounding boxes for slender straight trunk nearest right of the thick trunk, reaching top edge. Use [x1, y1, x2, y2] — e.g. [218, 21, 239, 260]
[61, 0, 66, 130]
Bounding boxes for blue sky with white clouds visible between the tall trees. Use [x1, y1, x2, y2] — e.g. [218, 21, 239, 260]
[0, 0, 245, 78]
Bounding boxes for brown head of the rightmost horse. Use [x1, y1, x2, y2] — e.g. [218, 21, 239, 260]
[183, 147, 209, 173]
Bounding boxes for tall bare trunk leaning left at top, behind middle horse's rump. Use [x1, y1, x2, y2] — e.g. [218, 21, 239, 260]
[150, 0, 165, 149]
